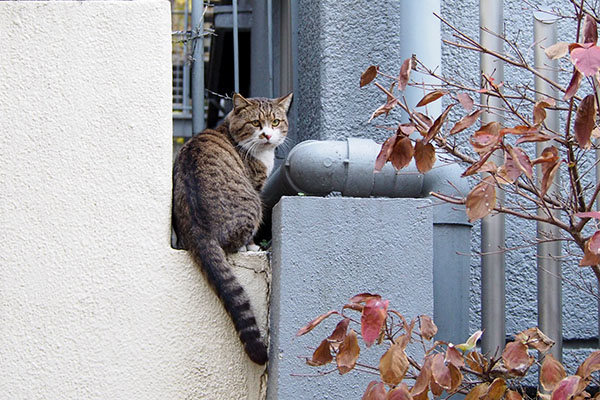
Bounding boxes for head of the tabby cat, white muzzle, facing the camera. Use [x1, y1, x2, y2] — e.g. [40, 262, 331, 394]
[227, 93, 292, 153]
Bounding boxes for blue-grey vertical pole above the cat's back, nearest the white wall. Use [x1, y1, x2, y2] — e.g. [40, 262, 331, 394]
[192, 0, 204, 134]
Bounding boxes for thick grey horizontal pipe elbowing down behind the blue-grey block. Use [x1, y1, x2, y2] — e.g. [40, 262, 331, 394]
[262, 138, 471, 343]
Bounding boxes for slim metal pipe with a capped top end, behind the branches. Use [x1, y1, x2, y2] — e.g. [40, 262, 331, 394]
[533, 11, 562, 360]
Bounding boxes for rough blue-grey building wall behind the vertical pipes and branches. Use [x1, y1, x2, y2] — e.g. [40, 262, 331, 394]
[295, 0, 598, 376]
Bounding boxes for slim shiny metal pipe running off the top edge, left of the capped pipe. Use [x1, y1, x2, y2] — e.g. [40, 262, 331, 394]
[479, 0, 506, 355]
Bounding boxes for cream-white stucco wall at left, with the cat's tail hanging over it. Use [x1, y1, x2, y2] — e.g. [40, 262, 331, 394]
[0, 0, 267, 399]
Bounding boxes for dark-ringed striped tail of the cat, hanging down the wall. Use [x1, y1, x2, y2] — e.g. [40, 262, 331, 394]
[189, 235, 268, 365]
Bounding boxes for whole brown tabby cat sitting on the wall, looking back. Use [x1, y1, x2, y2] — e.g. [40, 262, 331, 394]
[173, 93, 292, 364]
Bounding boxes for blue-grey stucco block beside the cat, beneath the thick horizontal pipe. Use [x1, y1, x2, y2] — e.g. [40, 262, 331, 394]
[268, 197, 433, 400]
